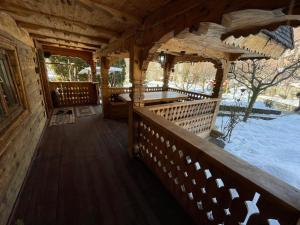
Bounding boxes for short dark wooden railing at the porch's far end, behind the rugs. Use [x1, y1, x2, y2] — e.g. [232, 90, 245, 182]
[49, 82, 99, 107]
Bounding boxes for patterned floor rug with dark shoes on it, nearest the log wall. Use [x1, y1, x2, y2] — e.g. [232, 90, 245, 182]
[50, 107, 75, 126]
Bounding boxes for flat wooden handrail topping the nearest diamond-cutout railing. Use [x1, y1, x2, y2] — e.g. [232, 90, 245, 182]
[134, 107, 300, 213]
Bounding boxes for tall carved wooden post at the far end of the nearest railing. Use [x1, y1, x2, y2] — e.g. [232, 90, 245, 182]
[128, 45, 146, 157]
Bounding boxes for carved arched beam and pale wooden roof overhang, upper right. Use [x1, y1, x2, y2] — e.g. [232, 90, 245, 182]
[97, 1, 300, 67]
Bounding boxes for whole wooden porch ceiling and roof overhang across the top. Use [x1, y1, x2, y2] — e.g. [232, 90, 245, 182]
[0, 0, 300, 64]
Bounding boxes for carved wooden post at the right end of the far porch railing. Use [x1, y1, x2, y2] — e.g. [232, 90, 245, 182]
[101, 57, 110, 118]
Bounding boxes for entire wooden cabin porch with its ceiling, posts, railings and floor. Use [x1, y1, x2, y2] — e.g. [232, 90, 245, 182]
[0, 0, 300, 225]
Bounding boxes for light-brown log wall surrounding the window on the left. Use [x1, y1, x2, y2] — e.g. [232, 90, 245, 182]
[0, 14, 47, 225]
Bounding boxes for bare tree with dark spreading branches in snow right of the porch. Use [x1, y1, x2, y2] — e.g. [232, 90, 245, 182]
[232, 54, 300, 122]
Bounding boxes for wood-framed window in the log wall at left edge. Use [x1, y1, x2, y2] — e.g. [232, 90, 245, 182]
[0, 49, 23, 132]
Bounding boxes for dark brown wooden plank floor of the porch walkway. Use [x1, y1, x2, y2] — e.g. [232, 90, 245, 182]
[11, 107, 192, 225]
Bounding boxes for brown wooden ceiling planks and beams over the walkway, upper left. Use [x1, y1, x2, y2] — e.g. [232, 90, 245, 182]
[0, 0, 169, 52]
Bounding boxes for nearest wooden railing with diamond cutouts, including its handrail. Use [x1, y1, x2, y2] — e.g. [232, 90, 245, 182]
[133, 108, 300, 225]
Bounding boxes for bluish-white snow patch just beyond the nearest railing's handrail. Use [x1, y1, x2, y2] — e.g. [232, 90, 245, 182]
[217, 114, 300, 189]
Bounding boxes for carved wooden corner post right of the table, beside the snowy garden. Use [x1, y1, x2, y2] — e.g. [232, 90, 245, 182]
[211, 60, 230, 129]
